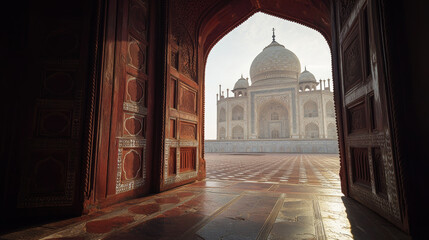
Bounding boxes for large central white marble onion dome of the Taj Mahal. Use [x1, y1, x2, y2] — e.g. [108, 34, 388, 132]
[250, 41, 301, 85]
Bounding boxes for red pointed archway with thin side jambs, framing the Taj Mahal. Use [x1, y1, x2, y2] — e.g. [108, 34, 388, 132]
[191, 0, 348, 195]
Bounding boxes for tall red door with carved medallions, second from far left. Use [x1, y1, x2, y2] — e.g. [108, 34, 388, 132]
[90, 0, 155, 205]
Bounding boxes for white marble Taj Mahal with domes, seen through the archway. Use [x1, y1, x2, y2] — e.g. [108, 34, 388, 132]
[206, 29, 338, 152]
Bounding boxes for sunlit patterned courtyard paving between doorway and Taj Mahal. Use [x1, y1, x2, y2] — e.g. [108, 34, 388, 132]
[206, 153, 340, 188]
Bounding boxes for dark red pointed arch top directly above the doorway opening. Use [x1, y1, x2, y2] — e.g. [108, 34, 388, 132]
[199, 0, 331, 62]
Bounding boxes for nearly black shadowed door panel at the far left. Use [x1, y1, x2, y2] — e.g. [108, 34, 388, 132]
[4, 1, 90, 218]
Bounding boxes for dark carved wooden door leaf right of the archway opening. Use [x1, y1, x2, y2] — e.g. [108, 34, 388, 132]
[336, 0, 406, 232]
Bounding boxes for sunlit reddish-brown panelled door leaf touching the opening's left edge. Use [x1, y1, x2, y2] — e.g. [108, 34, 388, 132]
[160, 1, 202, 190]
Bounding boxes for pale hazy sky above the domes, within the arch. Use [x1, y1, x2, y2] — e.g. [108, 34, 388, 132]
[205, 13, 332, 139]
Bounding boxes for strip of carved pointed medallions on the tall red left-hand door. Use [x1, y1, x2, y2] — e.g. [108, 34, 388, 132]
[108, 0, 149, 195]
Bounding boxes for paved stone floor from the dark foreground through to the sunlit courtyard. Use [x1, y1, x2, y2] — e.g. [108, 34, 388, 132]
[0, 154, 409, 240]
